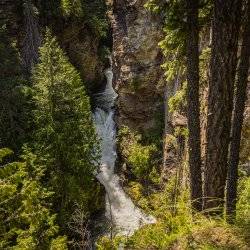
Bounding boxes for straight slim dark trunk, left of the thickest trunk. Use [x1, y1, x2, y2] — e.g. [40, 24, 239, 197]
[186, 0, 202, 211]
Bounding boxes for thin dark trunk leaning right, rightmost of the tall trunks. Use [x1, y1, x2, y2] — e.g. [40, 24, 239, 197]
[226, 0, 250, 222]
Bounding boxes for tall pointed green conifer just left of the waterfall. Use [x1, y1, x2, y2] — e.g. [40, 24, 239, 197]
[33, 30, 98, 227]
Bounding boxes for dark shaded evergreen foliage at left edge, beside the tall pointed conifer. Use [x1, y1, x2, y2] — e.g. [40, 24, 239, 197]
[0, 25, 30, 153]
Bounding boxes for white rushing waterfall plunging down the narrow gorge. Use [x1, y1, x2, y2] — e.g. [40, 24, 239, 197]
[94, 63, 155, 235]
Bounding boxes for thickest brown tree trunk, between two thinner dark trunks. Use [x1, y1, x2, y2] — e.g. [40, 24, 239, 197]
[204, 0, 242, 214]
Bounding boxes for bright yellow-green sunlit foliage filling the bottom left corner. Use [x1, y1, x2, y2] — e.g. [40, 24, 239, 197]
[0, 149, 66, 249]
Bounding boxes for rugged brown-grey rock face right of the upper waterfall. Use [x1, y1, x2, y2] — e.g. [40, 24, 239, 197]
[107, 0, 164, 131]
